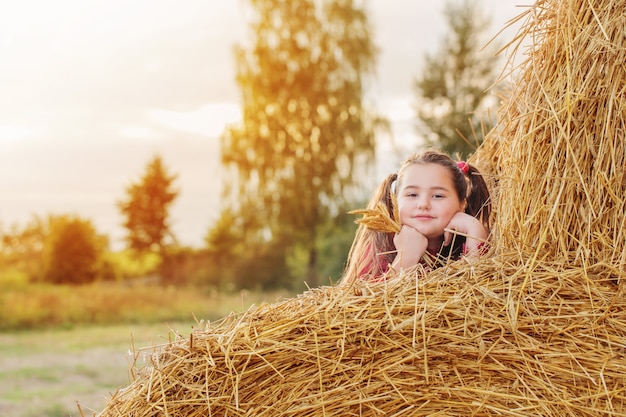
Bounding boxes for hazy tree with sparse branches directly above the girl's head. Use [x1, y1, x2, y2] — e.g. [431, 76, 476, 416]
[415, 0, 498, 156]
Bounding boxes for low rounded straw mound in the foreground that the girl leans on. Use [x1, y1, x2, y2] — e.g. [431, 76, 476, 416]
[101, 258, 626, 417]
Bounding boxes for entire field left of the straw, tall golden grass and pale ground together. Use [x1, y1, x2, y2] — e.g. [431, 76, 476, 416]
[0, 286, 288, 417]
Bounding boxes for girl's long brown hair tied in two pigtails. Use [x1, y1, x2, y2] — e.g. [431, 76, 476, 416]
[342, 149, 491, 281]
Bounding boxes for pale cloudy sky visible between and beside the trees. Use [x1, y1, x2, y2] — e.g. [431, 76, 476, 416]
[0, 0, 527, 248]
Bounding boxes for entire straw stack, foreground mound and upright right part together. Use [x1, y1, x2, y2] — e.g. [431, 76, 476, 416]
[94, 0, 626, 417]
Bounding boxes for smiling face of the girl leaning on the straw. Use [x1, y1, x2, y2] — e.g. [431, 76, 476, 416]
[397, 164, 465, 248]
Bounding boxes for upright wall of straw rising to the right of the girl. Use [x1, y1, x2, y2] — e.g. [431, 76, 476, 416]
[483, 0, 626, 275]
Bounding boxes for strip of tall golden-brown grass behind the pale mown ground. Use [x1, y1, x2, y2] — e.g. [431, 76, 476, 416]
[0, 283, 289, 331]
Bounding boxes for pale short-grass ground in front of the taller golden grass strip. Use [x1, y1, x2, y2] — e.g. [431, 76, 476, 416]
[0, 324, 190, 417]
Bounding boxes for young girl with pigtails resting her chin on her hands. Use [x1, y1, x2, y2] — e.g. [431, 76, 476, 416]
[343, 150, 491, 282]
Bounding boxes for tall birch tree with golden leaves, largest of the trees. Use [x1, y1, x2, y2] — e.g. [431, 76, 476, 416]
[221, 0, 376, 285]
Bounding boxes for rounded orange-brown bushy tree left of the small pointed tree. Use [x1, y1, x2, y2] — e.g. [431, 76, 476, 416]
[43, 216, 108, 284]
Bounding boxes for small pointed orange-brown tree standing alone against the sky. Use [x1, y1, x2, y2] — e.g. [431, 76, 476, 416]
[118, 155, 178, 256]
